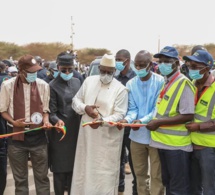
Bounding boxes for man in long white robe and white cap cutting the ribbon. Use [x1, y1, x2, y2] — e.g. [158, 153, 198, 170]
[71, 54, 128, 195]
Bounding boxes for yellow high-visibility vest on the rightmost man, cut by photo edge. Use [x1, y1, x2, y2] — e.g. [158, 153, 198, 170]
[191, 82, 215, 147]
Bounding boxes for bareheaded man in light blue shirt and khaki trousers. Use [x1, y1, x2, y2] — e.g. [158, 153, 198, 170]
[120, 50, 164, 195]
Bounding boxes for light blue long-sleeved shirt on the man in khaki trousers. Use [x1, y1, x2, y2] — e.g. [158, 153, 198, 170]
[125, 72, 164, 144]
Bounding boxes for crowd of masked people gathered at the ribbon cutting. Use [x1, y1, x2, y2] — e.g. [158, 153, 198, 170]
[0, 45, 215, 195]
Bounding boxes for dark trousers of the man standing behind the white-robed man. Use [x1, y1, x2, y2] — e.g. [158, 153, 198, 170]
[118, 133, 137, 195]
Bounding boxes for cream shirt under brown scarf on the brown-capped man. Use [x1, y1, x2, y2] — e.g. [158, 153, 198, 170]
[0, 77, 50, 122]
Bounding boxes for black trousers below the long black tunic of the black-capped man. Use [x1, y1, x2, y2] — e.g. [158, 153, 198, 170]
[53, 172, 73, 195]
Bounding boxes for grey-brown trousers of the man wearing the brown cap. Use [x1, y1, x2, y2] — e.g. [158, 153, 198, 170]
[8, 145, 50, 195]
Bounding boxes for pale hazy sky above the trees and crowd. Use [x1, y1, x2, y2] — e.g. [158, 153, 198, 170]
[0, 0, 215, 58]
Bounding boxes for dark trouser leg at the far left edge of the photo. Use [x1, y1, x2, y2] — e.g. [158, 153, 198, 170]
[0, 140, 7, 195]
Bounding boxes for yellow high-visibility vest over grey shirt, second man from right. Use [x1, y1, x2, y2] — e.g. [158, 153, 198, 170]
[151, 76, 195, 146]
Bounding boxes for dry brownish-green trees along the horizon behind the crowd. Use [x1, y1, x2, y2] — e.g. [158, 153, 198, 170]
[0, 42, 215, 65]
